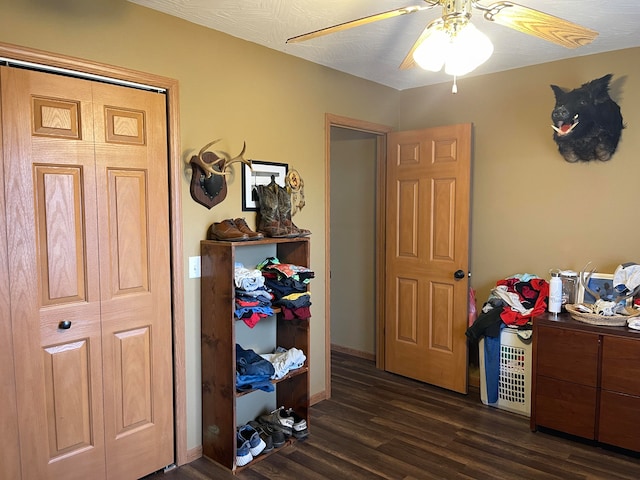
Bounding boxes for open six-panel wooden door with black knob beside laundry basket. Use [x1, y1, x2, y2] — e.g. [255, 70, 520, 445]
[385, 124, 471, 393]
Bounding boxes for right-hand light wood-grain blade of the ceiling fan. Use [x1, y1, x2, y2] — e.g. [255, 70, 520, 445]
[482, 2, 598, 48]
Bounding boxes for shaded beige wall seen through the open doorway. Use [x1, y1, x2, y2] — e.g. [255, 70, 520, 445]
[330, 127, 377, 355]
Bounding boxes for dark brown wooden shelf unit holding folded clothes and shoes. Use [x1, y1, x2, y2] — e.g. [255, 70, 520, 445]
[200, 237, 310, 471]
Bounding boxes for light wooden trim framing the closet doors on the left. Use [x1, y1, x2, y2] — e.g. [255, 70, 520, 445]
[0, 42, 188, 465]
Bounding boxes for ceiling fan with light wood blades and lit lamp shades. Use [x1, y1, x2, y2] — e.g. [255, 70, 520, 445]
[286, 0, 598, 76]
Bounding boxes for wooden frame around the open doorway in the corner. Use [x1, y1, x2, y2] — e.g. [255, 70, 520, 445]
[324, 113, 393, 403]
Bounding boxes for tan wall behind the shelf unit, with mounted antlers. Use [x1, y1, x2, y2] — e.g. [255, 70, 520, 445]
[0, 0, 399, 449]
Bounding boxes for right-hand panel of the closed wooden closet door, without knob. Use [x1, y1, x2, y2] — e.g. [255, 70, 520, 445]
[94, 80, 173, 479]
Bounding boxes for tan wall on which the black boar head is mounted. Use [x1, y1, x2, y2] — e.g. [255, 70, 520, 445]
[400, 48, 640, 304]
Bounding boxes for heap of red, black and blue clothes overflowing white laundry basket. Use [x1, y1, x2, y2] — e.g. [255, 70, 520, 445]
[465, 273, 549, 403]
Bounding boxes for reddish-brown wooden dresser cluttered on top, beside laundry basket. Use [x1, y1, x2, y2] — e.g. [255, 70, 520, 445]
[531, 314, 640, 451]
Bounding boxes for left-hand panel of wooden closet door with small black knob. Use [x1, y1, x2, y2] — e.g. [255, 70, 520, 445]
[1, 67, 105, 479]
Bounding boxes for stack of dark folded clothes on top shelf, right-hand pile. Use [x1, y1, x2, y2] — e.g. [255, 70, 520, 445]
[256, 257, 315, 320]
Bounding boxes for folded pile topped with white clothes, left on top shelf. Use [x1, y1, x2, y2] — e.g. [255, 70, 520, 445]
[234, 262, 273, 328]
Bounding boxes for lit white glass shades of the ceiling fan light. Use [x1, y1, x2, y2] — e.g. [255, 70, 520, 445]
[413, 22, 493, 76]
